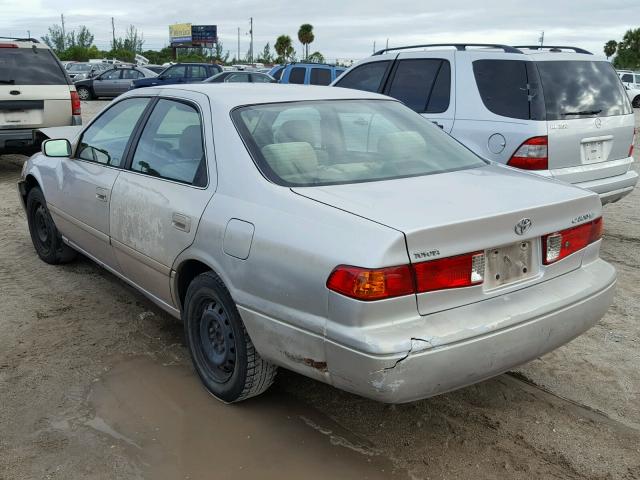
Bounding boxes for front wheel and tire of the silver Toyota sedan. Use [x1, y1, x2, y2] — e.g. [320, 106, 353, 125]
[27, 187, 76, 265]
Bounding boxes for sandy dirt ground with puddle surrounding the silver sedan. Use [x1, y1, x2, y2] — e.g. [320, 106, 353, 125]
[0, 102, 640, 480]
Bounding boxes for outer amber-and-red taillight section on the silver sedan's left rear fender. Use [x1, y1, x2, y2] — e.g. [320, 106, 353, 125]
[327, 265, 415, 300]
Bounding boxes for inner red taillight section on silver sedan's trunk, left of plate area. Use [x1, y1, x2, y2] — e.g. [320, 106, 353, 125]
[413, 252, 484, 293]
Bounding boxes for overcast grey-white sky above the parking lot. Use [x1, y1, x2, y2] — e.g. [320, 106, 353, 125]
[0, 0, 640, 61]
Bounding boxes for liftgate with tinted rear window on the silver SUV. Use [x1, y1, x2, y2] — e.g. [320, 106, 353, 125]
[535, 60, 634, 182]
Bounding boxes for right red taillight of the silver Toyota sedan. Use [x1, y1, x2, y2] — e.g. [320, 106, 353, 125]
[542, 217, 603, 265]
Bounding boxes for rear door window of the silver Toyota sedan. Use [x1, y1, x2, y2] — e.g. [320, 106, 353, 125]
[131, 99, 207, 187]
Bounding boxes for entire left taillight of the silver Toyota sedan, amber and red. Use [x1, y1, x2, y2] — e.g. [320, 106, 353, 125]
[327, 252, 484, 301]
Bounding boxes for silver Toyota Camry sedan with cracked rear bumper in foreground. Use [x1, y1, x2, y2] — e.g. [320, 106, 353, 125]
[19, 83, 616, 403]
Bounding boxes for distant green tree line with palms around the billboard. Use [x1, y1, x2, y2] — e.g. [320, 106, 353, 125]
[41, 23, 324, 65]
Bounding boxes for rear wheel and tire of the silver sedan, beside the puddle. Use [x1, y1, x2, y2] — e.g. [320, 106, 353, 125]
[182, 272, 277, 403]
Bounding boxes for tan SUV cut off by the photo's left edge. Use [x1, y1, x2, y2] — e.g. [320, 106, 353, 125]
[0, 38, 82, 153]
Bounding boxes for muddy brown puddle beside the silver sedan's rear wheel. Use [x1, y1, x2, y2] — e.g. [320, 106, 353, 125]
[87, 358, 406, 480]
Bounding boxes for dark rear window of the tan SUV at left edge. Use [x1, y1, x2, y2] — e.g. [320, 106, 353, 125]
[0, 48, 68, 85]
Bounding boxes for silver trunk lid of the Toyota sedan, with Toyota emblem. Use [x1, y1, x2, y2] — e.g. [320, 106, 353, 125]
[292, 165, 601, 315]
